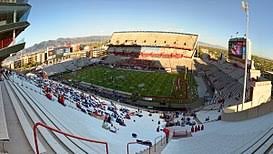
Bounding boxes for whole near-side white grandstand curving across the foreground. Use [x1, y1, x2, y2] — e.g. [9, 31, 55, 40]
[0, 70, 273, 154]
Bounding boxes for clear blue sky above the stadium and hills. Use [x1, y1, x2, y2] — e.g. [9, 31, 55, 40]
[19, 0, 273, 59]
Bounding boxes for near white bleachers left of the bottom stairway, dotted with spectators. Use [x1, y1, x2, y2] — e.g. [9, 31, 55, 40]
[1, 72, 169, 154]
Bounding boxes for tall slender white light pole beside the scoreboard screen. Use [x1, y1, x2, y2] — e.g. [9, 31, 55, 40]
[242, 0, 249, 110]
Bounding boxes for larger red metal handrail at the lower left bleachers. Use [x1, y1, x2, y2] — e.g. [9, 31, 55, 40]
[33, 122, 109, 154]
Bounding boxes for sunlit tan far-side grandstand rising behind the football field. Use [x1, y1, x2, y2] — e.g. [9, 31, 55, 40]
[108, 31, 198, 71]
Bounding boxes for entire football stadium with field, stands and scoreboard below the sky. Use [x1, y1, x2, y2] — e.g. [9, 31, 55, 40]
[0, 0, 273, 154]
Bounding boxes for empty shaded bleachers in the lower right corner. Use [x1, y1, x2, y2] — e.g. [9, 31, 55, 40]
[162, 109, 273, 154]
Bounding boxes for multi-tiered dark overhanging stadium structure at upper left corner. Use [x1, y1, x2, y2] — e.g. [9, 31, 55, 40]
[0, 0, 31, 60]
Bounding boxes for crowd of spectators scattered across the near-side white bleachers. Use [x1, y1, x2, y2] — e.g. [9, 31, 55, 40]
[7, 73, 185, 137]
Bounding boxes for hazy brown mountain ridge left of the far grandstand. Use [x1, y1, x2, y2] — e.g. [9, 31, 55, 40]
[18, 36, 111, 54]
